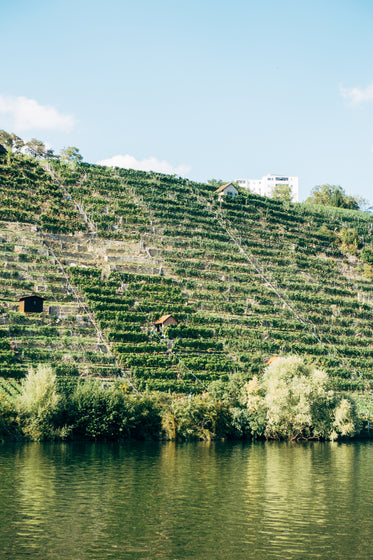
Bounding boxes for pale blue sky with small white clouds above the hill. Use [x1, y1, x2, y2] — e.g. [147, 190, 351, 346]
[0, 0, 373, 204]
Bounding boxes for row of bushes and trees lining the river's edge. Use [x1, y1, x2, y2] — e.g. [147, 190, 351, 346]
[0, 356, 373, 441]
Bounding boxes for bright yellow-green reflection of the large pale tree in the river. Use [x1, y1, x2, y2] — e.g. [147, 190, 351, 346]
[247, 442, 328, 559]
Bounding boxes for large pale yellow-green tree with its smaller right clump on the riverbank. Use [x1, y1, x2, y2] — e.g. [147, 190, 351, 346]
[241, 356, 358, 440]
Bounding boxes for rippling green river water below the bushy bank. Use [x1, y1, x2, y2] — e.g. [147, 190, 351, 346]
[0, 442, 373, 560]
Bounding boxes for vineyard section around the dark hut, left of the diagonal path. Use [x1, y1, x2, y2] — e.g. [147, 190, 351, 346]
[0, 222, 125, 378]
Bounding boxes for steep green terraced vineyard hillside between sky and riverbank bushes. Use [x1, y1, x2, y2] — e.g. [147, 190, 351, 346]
[0, 150, 373, 393]
